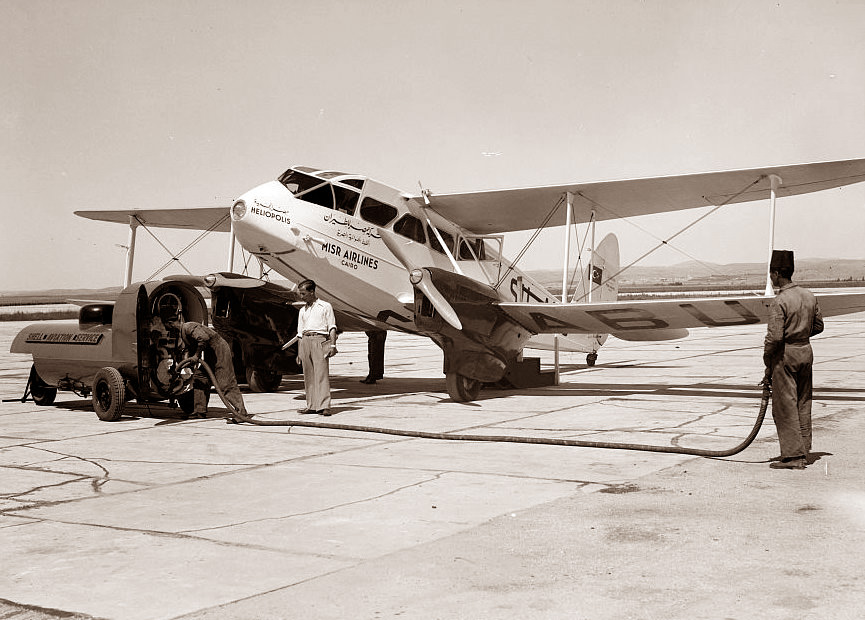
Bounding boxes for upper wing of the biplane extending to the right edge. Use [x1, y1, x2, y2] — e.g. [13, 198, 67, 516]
[412, 159, 865, 234]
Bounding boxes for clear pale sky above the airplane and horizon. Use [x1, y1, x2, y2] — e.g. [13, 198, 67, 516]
[0, 0, 865, 291]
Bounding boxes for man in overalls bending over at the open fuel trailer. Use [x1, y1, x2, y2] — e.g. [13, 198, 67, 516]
[160, 313, 252, 424]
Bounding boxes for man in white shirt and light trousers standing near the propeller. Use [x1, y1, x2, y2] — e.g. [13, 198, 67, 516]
[297, 280, 336, 416]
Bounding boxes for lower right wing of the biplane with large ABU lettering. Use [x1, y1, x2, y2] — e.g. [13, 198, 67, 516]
[498, 293, 865, 340]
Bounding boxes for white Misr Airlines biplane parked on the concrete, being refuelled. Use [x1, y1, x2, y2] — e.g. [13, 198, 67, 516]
[76, 159, 865, 402]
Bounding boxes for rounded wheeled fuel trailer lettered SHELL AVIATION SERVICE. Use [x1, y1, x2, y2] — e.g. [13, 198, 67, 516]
[10, 280, 208, 421]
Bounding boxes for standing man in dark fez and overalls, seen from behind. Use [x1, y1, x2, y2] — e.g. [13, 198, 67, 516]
[763, 250, 823, 469]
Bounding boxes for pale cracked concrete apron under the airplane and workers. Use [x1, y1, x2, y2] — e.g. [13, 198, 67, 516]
[0, 314, 865, 620]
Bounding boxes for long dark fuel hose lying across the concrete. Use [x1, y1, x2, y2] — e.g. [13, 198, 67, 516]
[177, 358, 772, 458]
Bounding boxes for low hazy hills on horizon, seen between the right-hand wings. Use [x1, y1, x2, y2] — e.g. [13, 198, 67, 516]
[529, 258, 865, 289]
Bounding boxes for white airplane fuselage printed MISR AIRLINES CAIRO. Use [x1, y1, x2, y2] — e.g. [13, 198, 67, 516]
[232, 168, 556, 331]
